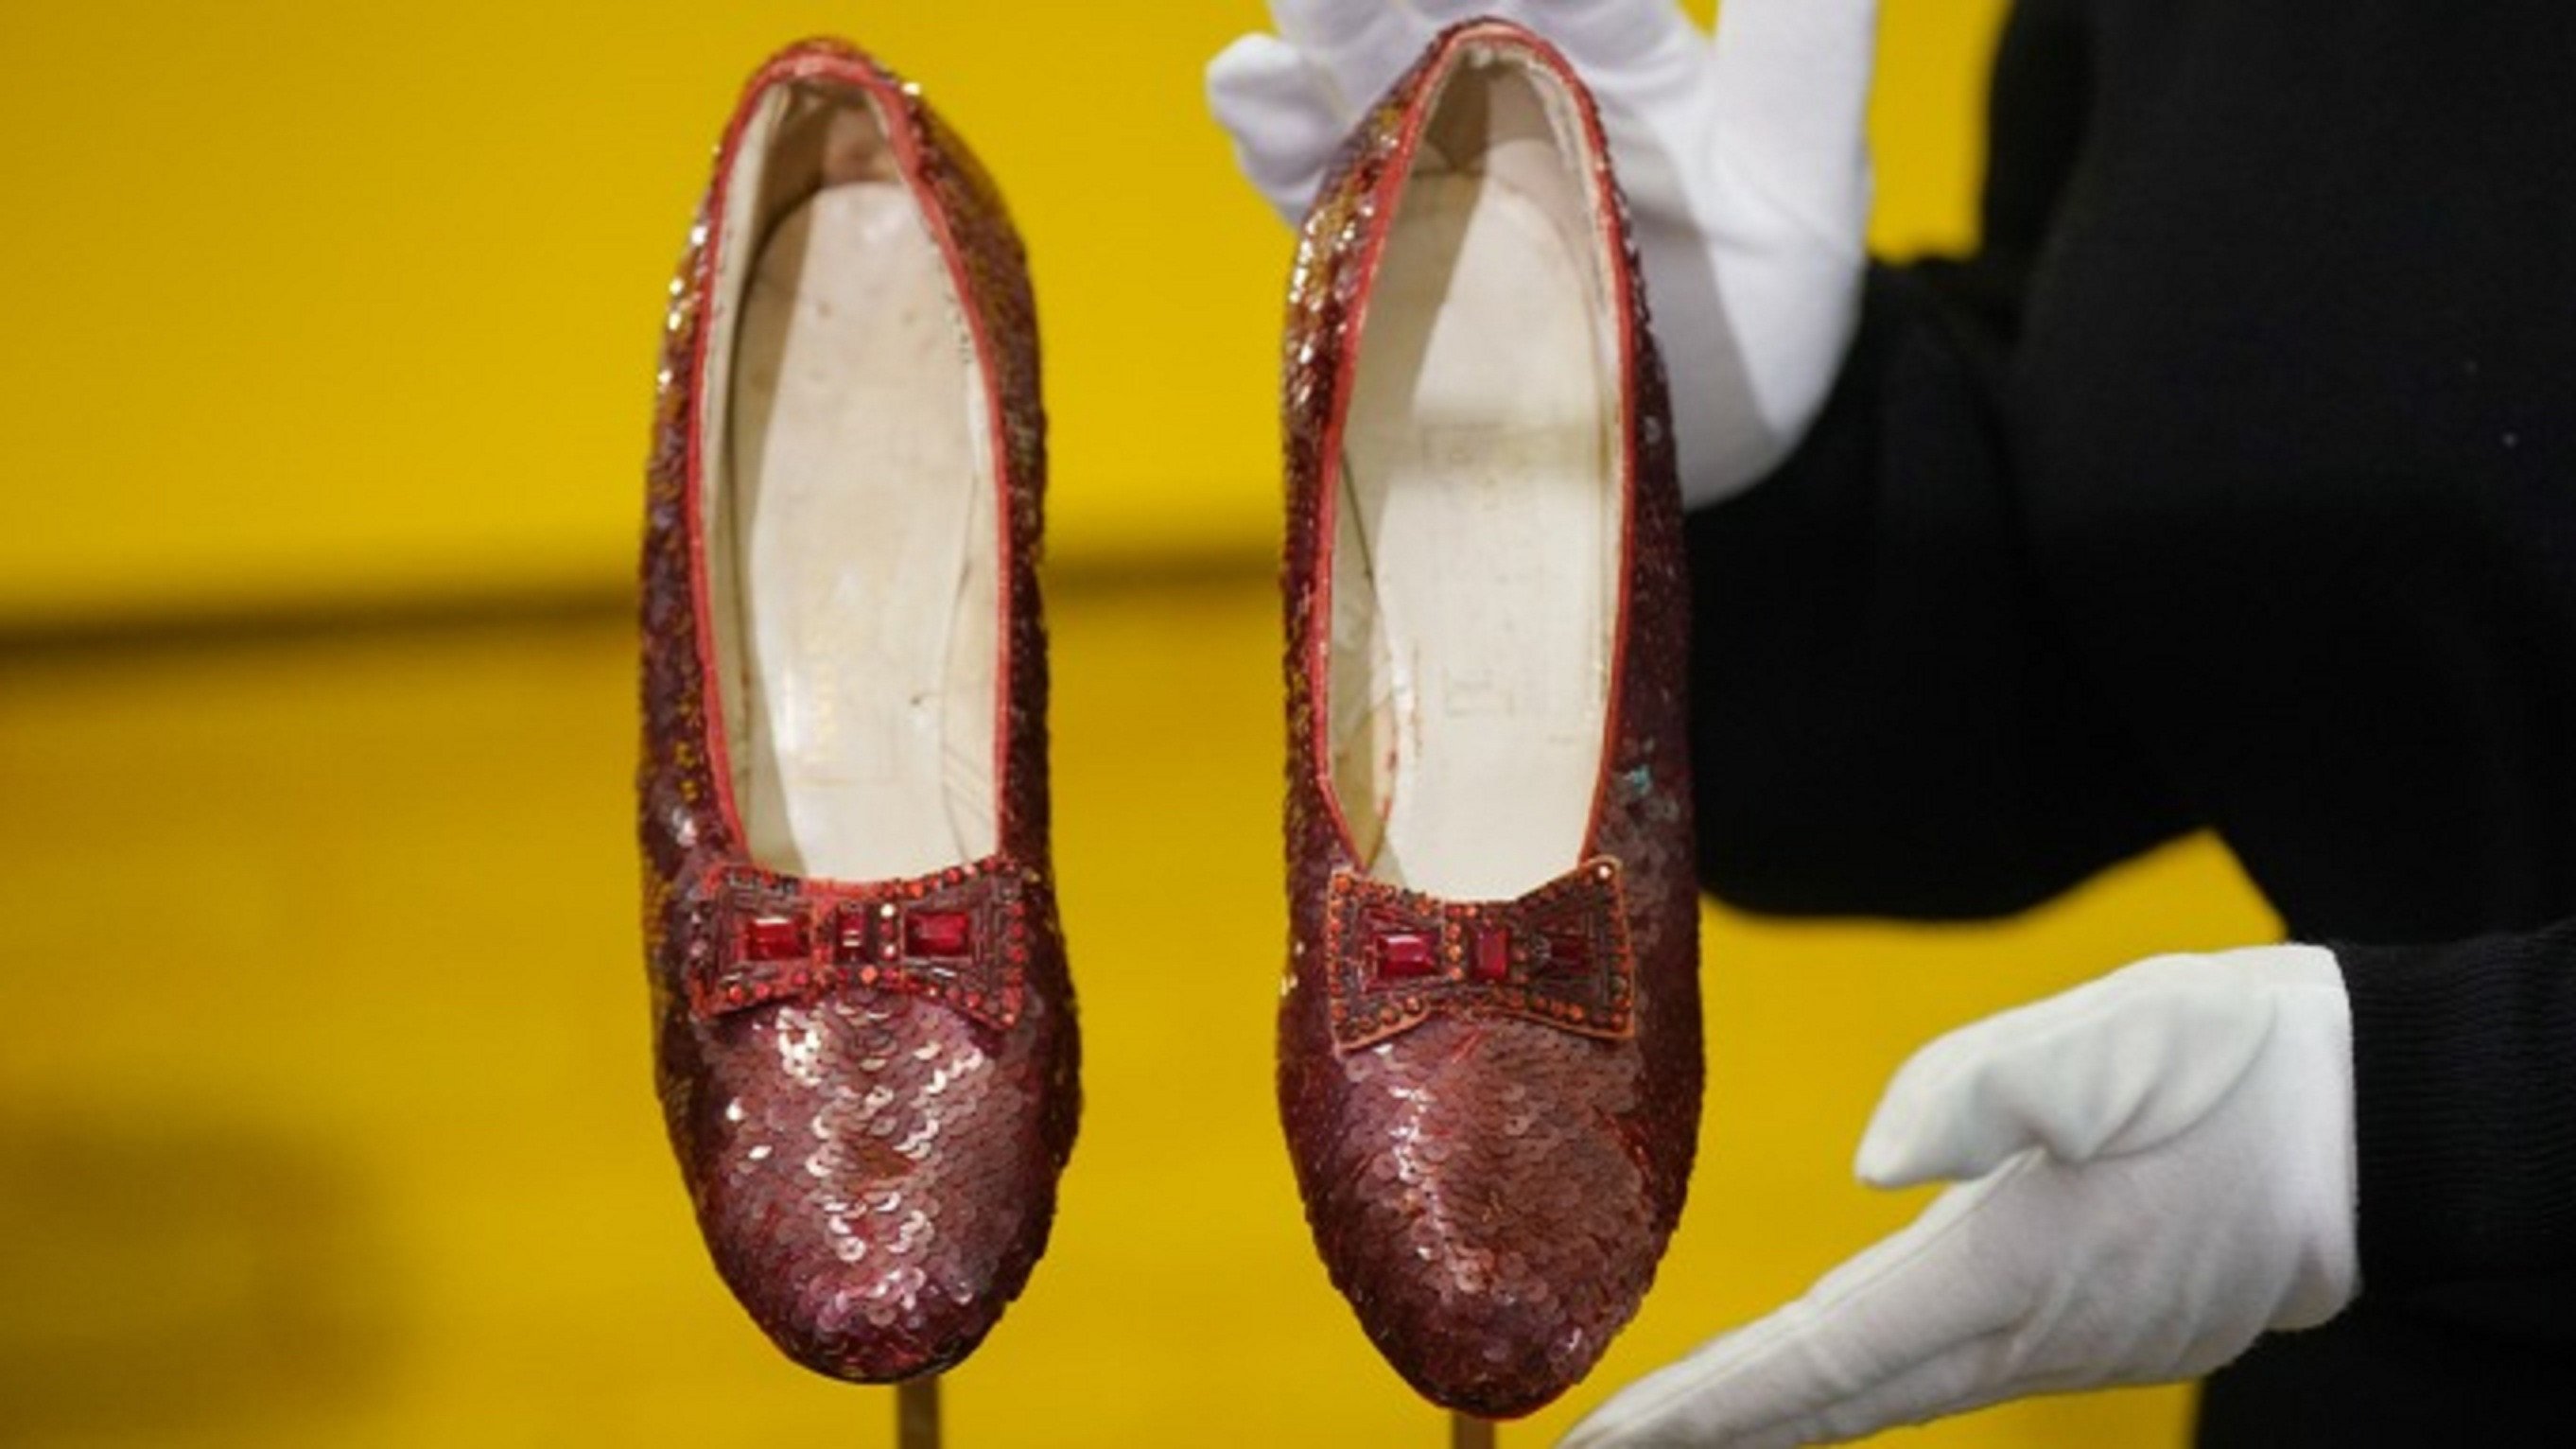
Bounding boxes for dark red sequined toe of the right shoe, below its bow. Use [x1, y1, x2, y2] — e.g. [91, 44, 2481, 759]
[1309, 1021, 1666, 1418]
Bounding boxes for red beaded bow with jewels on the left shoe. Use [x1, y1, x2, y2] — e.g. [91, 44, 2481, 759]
[688, 856, 1046, 1031]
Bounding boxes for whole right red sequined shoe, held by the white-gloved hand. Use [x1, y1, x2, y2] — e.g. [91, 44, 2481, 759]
[1278, 21, 1700, 1418]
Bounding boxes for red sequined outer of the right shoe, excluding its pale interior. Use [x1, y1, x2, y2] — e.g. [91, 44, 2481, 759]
[1278, 21, 1700, 1416]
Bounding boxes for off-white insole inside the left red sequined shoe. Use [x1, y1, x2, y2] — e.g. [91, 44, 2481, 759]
[737, 181, 1000, 882]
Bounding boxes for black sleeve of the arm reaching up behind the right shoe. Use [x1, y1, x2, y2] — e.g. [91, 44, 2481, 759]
[1687, 0, 2187, 917]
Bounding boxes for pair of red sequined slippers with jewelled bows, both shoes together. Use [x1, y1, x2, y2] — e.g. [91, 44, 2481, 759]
[641, 21, 1700, 1416]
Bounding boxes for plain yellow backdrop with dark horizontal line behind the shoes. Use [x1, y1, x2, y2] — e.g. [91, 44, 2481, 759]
[0, 0, 2274, 1449]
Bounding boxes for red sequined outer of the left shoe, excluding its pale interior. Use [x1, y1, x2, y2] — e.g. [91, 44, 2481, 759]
[653, 42, 1079, 1382]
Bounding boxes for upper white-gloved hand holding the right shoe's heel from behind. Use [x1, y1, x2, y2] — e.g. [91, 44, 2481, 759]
[1209, 0, 1878, 505]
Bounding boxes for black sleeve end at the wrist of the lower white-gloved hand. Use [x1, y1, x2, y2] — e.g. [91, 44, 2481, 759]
[2334, 920, 2576, 1338]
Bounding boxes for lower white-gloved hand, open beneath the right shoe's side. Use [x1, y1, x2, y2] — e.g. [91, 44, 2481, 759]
[1563, 946, 2359, 1449]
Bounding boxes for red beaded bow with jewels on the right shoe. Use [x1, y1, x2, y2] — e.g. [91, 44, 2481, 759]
[1324, 856, 1636, 1052]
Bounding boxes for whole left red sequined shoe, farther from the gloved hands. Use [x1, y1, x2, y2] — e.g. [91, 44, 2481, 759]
[639, 42, 1077, 1382]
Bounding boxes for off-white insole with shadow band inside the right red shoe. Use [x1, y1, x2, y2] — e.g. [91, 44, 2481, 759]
[1332, 173, 1620, 899]
